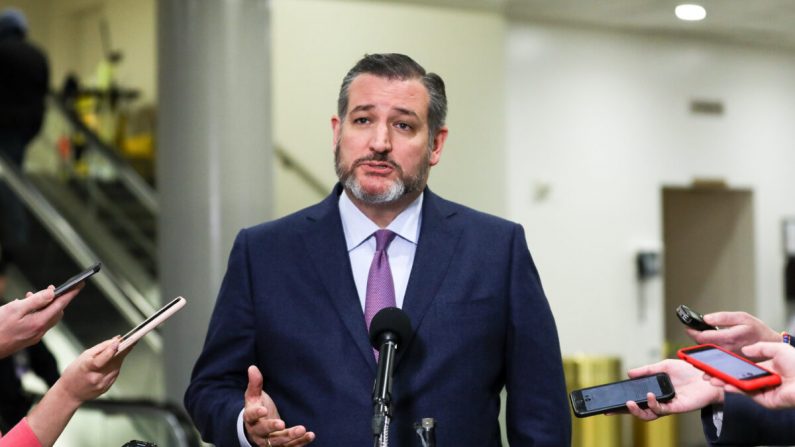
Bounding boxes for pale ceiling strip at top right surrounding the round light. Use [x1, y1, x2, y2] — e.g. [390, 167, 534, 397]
[394, 0, 795, 50]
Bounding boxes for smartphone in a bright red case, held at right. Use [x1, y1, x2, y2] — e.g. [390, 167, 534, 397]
[677, 345, 781, 391]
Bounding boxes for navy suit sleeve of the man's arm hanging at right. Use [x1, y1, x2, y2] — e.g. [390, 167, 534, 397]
[506, 225, 571, 446]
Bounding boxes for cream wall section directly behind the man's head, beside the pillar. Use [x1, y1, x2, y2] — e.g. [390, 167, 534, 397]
[272, 0, 505, 215]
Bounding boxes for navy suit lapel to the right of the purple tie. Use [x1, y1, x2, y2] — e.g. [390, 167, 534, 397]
[396, 189, 461, 365]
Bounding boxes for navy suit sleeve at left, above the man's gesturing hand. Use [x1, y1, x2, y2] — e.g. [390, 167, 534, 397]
[185, 230, 257, 447]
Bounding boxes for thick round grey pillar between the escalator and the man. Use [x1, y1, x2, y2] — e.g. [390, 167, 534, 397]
[157, 0, 273, 404]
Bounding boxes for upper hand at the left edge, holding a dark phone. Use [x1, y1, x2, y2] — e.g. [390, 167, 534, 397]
[0, 286, 81, 358]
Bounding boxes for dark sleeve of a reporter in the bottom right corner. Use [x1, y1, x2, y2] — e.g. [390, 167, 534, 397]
[701, 393, 795, 446]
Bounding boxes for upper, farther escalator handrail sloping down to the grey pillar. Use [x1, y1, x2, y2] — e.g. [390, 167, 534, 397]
[50, 93, 160, 216]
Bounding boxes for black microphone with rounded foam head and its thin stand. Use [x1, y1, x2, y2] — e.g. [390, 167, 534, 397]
[370, 307, 411, 440]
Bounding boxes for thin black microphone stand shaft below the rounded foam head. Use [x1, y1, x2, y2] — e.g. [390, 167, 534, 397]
[372, 338, 397, 447]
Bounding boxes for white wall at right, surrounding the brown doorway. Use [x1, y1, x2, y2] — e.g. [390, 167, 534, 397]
[506, 23, 795, 365]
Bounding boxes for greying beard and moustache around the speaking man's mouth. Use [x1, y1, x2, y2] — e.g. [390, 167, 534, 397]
[334, 143, 431, 204]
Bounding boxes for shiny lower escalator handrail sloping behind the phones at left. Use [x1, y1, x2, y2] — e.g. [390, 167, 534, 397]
[0, 153, 163, 353]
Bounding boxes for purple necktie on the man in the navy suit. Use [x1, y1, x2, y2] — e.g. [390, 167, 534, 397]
[364, 230, 396, 360]
